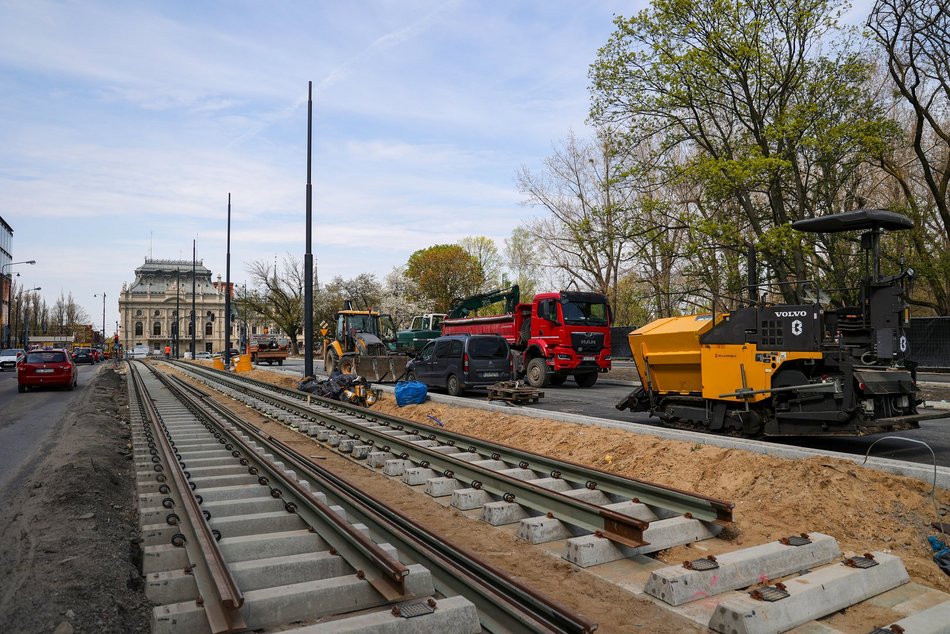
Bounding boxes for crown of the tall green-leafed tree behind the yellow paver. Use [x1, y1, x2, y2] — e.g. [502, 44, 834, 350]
[590, 0, 894, 301]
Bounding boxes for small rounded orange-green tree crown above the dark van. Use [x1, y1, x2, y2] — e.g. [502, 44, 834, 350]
[406, 244, 485, 312]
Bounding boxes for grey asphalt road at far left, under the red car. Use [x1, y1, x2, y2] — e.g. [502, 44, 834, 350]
[0, 363, 103, 500]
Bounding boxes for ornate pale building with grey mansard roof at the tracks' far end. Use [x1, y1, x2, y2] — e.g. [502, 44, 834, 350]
[119, 258, 236, 356]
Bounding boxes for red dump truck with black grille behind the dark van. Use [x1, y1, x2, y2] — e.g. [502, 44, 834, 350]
[442, 285, 611, 387]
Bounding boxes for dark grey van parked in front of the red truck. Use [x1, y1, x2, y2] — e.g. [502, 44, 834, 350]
[406, 335, 512, 396]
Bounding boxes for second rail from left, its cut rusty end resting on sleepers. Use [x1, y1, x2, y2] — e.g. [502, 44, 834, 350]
[152, 368, 412, 602]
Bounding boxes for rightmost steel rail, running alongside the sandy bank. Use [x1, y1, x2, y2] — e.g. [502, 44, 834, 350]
[173, 364, 735, 524]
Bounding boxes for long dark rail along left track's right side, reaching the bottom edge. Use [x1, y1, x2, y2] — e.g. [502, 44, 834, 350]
[163, 368, 597, 633]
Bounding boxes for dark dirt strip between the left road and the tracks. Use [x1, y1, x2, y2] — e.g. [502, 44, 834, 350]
[0, 368, 151, 634]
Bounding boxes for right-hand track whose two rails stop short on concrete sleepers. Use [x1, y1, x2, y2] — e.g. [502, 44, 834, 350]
[169, 364, 734, 553]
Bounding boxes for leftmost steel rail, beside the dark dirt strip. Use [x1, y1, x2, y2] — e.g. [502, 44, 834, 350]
[129, 363, 247, 634]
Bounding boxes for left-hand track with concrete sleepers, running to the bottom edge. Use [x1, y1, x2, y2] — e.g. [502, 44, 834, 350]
[128, 362, 596, 633]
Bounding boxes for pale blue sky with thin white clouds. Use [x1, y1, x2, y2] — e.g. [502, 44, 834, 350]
[0, 0, 867, 332]
